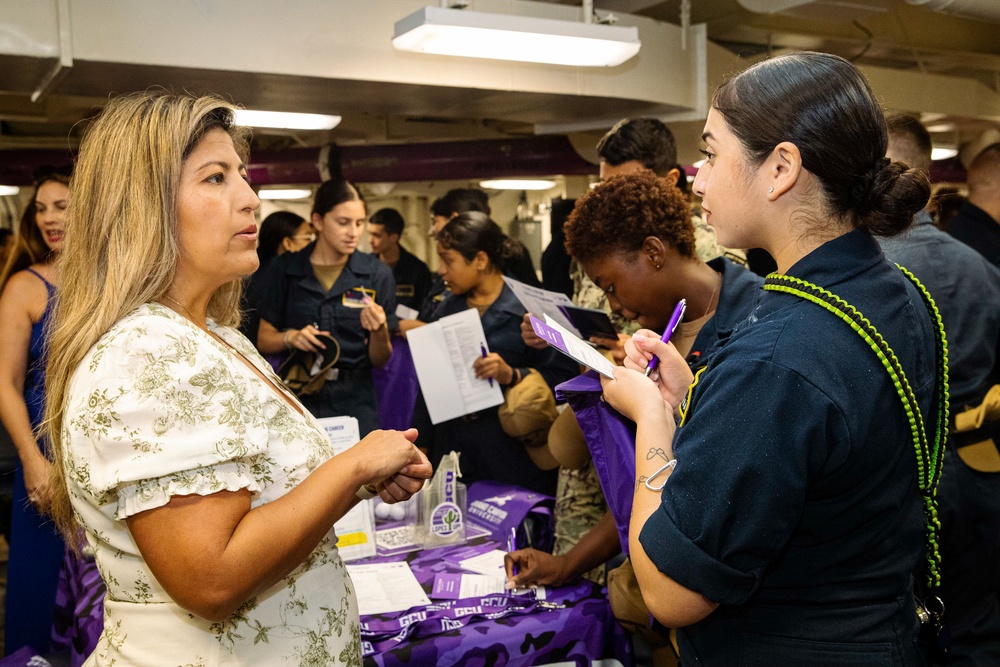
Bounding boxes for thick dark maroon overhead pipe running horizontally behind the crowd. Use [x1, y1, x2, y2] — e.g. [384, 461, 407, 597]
[0, 136, 597, 185]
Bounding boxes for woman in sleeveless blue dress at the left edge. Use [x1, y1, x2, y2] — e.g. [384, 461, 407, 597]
[0, 169, 69, 653]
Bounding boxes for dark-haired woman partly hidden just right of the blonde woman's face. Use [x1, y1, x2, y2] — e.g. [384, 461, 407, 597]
[240, 211, 316, 344]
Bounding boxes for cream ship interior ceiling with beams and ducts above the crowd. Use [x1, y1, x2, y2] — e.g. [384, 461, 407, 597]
[0, 0, 1000, 256]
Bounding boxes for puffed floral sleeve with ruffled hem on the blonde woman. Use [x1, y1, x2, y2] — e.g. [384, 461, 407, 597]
[65, 316, 268, 520]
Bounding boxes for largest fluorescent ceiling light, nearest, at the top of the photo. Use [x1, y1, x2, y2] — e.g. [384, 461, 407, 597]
[392, 7, 641, 67]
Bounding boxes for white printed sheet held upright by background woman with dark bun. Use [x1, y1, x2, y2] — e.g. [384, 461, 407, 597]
[406, 309, 503, 424]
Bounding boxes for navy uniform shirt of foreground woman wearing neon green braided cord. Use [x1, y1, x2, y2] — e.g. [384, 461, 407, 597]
[639, 231, 935, 666]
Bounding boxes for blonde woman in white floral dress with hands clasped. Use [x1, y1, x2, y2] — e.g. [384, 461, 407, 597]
[47, 94, 431, 667]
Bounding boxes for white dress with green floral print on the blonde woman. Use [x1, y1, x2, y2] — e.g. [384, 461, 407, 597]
[63, 304, 361, 667]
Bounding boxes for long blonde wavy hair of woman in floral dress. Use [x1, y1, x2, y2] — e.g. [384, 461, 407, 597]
[43, 92, 249, 542]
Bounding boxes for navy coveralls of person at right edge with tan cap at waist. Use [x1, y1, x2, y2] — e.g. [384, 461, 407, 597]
[881, 211, 1000, 666]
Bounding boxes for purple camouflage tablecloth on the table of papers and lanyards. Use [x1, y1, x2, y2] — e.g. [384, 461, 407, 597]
[359, 538, 634, 667]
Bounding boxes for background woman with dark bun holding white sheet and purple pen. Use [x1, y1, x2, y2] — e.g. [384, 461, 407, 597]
[413, 212, 579, 495]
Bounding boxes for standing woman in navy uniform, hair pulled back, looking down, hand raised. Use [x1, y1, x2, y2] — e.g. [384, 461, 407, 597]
[257, 180, 399, 436]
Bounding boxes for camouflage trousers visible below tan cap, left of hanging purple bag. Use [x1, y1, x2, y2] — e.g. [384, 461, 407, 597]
[552, 461, 608, 586]
